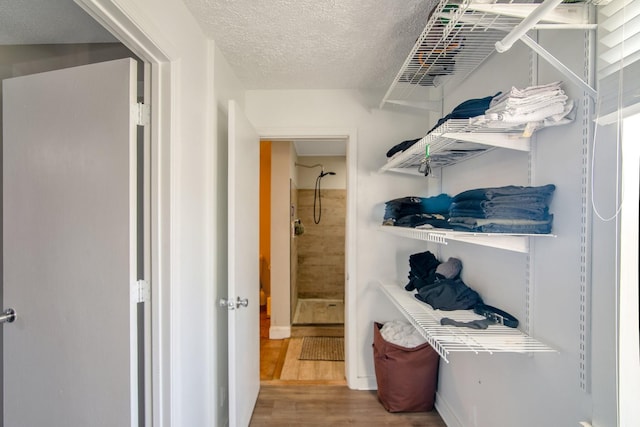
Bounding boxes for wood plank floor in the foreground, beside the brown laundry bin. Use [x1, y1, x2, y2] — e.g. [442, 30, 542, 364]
[249, 384, 446, 427]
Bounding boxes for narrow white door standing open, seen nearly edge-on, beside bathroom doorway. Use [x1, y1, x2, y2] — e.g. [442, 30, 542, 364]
[227, 101, 260, 427]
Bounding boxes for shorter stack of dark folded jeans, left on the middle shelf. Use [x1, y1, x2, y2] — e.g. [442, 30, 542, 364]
[382, 194, 452, 228]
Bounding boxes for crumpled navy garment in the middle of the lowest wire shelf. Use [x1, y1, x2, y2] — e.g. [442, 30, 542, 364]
[415, 278, 482, 311]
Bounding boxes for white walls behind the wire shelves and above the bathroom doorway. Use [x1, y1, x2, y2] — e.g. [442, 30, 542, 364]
[247, 28, 615, 427]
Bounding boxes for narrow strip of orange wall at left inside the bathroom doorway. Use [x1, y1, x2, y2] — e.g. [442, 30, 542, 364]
[260, 141, 271, 296]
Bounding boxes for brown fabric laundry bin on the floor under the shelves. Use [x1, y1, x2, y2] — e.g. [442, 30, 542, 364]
[373, 322, 440, 412]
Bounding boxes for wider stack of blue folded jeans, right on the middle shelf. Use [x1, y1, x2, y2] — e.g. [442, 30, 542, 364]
[449, 184, 555, 234]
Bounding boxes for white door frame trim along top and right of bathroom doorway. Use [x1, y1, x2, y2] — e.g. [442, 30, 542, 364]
[256, 127, 358, 388]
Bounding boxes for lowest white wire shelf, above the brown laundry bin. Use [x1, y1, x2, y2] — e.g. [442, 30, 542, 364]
[380, 283, 556, 363]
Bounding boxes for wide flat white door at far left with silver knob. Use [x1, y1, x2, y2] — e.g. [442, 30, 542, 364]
[3, 59, 138, 427]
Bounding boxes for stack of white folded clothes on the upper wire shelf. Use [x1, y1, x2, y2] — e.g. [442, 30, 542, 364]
[471, 82, 574, 132]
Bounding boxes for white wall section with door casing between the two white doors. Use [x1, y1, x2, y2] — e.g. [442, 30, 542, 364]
[76, 0, 226, 426]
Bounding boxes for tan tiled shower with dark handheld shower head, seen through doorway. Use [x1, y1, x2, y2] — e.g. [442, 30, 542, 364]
[291, 155, 347, 327]
